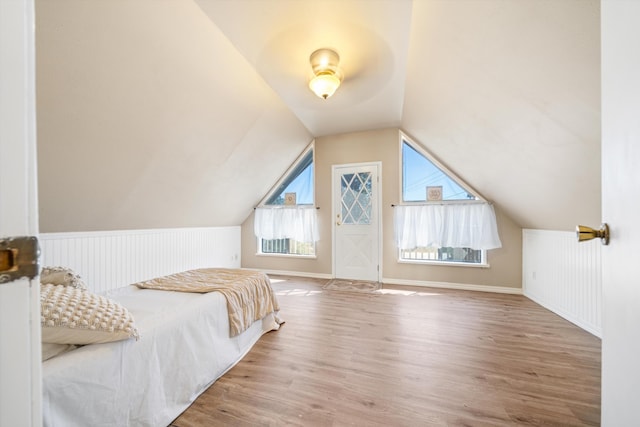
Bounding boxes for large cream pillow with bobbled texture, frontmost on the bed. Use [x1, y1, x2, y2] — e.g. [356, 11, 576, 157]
[40, 283, 140, 344]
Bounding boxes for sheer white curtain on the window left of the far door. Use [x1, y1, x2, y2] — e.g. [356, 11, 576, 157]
[253, 207, 319, 243]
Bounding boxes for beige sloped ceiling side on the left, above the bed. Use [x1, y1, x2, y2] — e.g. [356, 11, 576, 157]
[36, 0, 312, 232]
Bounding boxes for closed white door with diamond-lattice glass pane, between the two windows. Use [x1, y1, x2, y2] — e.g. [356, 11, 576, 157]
[332, 163, 380, 281]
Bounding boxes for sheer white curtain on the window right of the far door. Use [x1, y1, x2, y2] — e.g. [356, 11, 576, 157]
[393, 203, 502, 250]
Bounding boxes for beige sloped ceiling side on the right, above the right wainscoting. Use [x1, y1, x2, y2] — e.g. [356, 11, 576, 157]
[402, 0, 600, 230]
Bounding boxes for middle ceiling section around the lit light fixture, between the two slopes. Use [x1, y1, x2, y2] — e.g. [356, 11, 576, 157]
[197, 0, 412, 136]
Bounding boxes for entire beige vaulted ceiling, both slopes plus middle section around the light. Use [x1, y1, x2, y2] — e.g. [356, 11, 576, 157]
[36, 0, 600, 231]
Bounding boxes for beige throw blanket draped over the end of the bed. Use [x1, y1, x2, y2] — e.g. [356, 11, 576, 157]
[136, 268, 282, 337]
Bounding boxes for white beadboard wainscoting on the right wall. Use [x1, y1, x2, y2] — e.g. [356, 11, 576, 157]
[522, 229, 602, 337]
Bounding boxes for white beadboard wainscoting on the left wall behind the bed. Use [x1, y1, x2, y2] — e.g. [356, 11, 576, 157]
[40, 226, 240, 292]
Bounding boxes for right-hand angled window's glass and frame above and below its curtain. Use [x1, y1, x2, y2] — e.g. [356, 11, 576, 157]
[399, 138, 486, 265]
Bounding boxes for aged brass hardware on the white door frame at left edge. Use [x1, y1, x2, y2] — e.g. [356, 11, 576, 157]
[0, 236, 40, 283]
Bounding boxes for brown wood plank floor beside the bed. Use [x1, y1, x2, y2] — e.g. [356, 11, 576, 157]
[172, 276, 601, 427]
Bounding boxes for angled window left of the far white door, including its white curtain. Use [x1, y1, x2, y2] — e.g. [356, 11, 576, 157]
[256, 144, 316, 256]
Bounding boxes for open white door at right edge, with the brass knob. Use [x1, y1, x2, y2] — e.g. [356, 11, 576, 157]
[601, 0, 640, 427]
